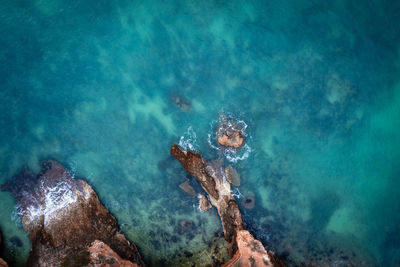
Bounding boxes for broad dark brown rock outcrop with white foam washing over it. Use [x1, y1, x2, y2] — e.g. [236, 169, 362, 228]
[1, 161, 144, 266]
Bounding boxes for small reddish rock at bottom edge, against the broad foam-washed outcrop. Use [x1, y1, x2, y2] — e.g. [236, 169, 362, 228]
[86, 240, 138, 267]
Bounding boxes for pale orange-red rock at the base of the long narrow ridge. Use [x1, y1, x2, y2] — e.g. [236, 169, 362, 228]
[222, 230, 285, 267]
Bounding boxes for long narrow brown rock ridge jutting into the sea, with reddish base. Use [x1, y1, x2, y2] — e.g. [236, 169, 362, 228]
[170, 144, 284, 266]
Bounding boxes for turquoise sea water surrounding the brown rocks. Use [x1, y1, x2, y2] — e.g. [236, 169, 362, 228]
[0, 0, 400, 266]
